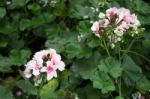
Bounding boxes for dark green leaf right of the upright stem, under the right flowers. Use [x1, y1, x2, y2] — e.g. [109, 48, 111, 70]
[123, 55, 142, 85]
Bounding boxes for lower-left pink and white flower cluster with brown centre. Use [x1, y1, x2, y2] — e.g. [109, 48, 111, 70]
[24, 49, 65, 80]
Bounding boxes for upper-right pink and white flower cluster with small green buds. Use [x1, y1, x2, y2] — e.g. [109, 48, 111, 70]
[91, 7, 140, 48]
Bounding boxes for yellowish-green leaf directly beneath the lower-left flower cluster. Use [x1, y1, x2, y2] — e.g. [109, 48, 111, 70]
[40, 79, 58, 99]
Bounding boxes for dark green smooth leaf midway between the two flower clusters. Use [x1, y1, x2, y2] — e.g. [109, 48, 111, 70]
[71, 52, 101, 79]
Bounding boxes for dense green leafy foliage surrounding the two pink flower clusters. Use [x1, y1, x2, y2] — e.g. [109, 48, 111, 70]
[0, 0, 150, 99]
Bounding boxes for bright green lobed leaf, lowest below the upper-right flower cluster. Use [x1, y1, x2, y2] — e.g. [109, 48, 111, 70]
[91, 70, 115, 93]
